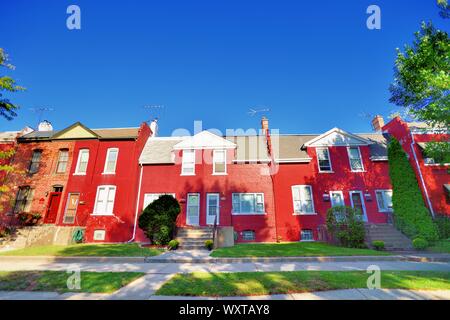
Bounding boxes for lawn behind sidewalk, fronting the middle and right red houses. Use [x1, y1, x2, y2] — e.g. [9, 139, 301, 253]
[211, 242, 388, 257]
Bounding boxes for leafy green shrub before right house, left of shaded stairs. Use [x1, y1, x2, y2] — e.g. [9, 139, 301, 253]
[327, 206, 366, 248]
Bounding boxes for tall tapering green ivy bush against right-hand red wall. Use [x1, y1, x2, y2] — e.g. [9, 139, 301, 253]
[388, 138, 439, 242]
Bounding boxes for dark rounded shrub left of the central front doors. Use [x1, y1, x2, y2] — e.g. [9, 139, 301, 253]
[139, 195, 180, 245]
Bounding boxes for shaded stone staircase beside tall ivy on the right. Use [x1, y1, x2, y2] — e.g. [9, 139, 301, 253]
[366, 224, 413, 251]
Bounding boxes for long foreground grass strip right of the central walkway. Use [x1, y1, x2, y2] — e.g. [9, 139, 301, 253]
[156, 271, 450, 296]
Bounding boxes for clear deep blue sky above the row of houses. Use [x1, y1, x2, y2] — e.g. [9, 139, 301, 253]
[0, 0, 448, 135]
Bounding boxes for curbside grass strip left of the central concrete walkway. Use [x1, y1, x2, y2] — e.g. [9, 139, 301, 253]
[0, 271, 144, 293]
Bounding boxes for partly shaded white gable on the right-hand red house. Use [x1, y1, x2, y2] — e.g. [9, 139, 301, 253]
[305, 128, 371, 147]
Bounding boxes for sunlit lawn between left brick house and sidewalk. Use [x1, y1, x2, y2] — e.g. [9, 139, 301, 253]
[0, 243, 162, 257]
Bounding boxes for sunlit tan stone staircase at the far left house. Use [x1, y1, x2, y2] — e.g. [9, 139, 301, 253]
[2, 224, 57, 250]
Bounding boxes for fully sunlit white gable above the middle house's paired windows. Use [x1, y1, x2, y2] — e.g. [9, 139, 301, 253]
[173, 131, 236, 150]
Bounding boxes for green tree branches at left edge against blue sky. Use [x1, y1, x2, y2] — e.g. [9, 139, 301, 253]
[0, 48, 25, 120]
